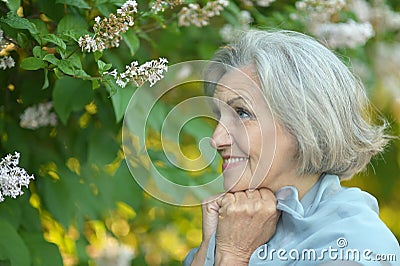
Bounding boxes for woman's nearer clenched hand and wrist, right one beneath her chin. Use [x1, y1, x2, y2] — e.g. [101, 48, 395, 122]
[215, 188, 280, 265]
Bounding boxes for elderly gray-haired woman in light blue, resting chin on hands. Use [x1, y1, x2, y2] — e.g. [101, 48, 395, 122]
[184, 30, 400, 265]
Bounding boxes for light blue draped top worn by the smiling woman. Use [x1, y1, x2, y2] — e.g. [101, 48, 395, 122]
[183, 174, 400, 265]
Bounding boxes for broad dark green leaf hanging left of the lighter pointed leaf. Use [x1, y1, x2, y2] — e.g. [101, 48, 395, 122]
[53, 77, 93, 124]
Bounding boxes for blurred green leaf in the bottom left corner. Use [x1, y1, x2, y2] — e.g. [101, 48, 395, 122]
[0, 218, 31, 266]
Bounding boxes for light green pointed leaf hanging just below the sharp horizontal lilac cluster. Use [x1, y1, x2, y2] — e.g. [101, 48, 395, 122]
[105, 79, 135, 122]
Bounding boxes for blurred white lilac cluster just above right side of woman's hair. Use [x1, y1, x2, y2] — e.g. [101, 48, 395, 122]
[312, 20, 375, 49]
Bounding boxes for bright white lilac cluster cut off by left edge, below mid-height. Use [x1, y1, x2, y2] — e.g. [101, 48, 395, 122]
[0, 152, 34, 202]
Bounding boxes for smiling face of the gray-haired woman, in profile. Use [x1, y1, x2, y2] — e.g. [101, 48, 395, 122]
[211, 66, 296, 192]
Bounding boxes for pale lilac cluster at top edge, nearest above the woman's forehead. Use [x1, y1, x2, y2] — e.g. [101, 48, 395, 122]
[178, 0, 229, 27]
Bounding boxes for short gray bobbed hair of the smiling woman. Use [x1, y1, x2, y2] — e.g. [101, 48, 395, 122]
[205, 30, 388, 179]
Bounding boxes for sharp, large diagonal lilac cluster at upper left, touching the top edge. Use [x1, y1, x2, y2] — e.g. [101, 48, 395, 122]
[78, 0, 137, 52]
